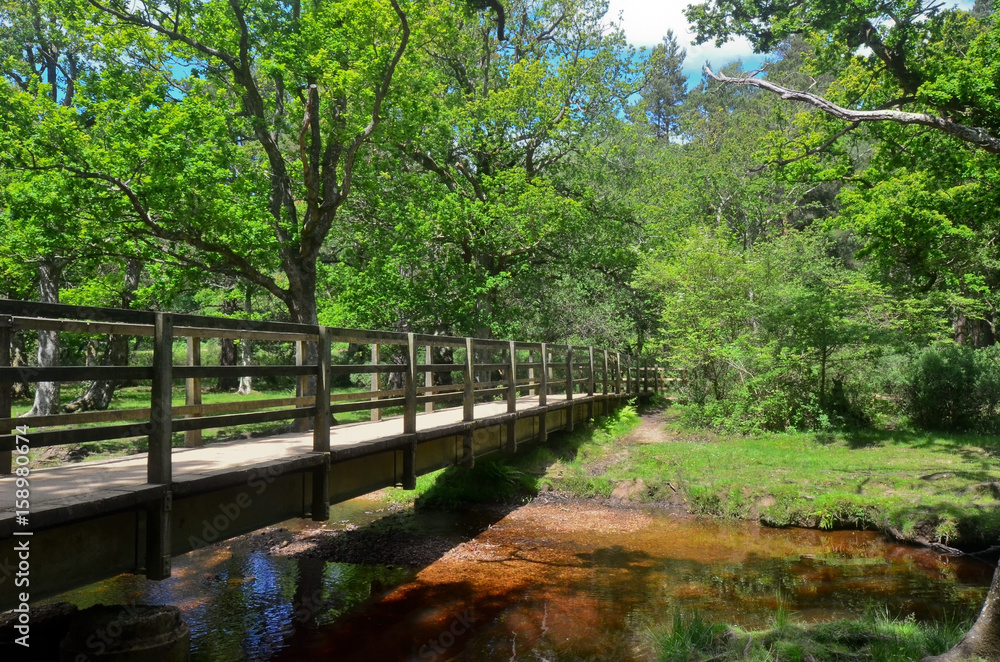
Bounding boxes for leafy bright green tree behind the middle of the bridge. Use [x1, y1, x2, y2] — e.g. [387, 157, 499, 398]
[326, 0, 641, 340]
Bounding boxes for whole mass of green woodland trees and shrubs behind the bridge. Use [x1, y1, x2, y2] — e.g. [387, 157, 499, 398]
[0, 0, 1000, 432]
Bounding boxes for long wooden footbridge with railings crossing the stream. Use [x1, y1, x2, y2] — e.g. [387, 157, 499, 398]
[0, 300, 663, 610]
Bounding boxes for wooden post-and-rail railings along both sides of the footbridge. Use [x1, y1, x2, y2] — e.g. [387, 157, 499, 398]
[0, 300, 662, 483]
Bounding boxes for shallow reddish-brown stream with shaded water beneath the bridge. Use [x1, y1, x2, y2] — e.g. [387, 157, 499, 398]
[41, 499, 992, 662]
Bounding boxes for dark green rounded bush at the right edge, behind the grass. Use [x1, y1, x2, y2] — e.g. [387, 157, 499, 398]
[904, 344, 1000, 432]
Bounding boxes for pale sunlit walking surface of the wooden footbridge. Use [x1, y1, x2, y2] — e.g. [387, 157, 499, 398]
[0, 395, 572, 531]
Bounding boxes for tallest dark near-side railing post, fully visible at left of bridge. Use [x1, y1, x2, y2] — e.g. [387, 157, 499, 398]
[146, 313, 174, 579]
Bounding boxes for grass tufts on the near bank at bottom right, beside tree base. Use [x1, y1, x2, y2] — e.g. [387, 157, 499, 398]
[645, 608, 971, 662]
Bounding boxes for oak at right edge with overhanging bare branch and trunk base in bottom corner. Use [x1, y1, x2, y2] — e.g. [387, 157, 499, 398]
[687, 0, 1000, 660]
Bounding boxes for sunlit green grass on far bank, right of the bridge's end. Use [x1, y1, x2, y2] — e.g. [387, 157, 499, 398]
[550, 408, 1000, 547]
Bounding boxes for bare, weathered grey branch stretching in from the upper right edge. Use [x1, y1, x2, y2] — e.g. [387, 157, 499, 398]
[705, 66, 1000, 154]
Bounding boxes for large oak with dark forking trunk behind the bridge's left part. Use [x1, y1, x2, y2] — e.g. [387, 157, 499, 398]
[2, 0, 410, 323]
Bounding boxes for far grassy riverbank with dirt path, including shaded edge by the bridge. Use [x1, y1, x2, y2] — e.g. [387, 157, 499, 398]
[417, 408, 1000, 557]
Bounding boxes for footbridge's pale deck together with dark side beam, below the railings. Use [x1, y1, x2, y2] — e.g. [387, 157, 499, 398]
[0, 394, 623, 610]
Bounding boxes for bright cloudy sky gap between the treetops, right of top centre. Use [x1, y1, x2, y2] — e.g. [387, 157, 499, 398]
[607, 0, 974, 84]
